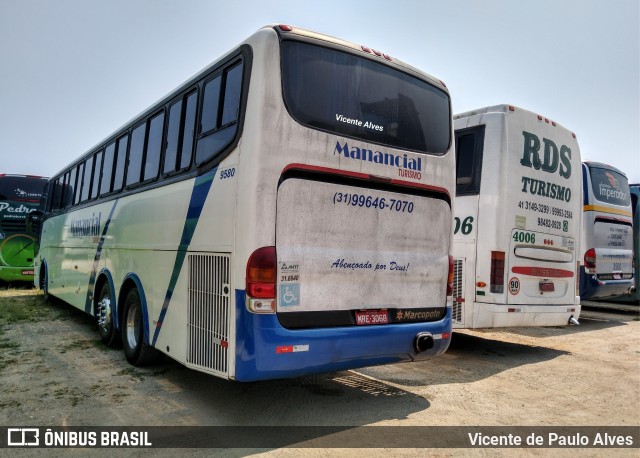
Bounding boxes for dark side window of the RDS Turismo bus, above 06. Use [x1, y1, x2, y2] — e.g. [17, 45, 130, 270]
[455, 125, 484, 196]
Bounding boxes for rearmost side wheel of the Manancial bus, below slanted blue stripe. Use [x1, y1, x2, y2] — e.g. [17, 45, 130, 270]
[122, 288, 158, 366]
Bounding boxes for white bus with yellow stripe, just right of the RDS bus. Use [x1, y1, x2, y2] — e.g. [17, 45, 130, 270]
[580, 162, 633, 300]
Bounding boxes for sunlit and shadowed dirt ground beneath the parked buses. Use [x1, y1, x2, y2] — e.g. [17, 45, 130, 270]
[0, 290, 640, 456]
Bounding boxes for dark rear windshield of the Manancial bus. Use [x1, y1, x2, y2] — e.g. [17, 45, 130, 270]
[282, 41, 451, 154]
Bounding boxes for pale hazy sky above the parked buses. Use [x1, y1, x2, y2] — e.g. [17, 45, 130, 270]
[0, 0, 640, 183]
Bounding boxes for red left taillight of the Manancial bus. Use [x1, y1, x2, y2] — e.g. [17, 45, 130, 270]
[245, 246, 278, 313]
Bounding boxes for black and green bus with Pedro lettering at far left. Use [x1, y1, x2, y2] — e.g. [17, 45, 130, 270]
[0, 174, 47, 283]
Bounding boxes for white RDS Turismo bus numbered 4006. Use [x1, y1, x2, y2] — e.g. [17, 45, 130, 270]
[453, 105, 582, 328]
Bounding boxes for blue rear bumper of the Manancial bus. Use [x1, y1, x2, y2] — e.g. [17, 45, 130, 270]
[234, 290, 451, 381]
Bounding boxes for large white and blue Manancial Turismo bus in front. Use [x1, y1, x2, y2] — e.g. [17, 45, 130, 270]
[36, 25, 455, 381]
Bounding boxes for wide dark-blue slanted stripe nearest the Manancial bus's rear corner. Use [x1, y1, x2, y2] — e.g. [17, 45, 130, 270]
[151, 168, 218, 346]
